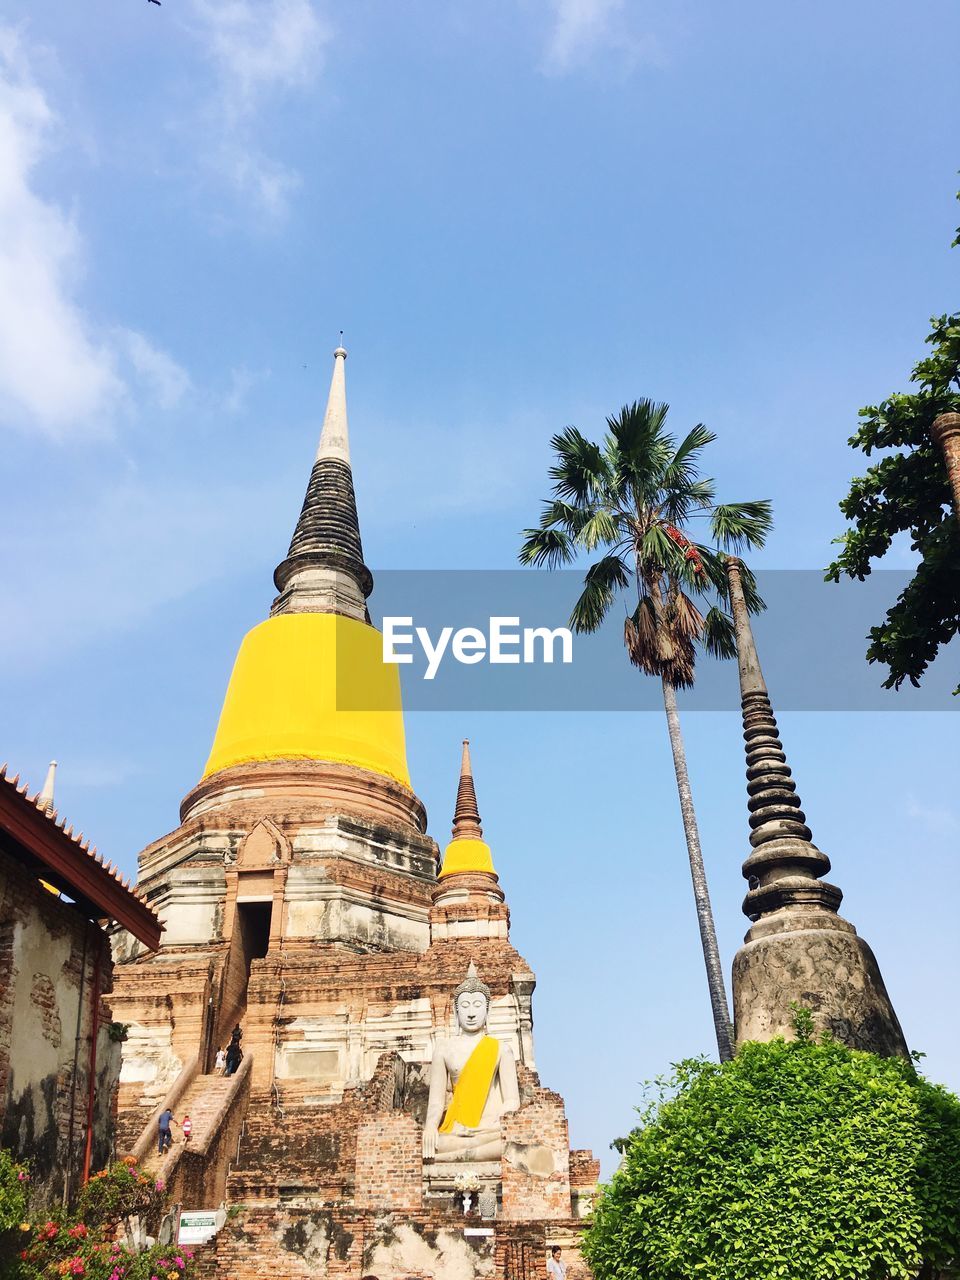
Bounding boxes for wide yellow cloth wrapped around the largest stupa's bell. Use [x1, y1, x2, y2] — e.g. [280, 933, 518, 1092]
[204, 613, 410, 787]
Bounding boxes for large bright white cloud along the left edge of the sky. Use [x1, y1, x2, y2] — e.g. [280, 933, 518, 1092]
[0, 27, 188, 439]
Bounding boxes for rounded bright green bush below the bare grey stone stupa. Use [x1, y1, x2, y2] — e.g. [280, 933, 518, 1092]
[584, 1038, 960, 1280]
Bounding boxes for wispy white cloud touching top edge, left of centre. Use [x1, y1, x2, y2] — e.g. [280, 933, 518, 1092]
[193, 0, 333, 220]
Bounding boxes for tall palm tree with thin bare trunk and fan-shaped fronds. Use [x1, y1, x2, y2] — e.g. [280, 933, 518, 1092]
[520, 399, 772, 1061]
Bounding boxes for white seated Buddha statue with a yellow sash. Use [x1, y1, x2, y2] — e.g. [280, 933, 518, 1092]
[424, 961, 520, 1160]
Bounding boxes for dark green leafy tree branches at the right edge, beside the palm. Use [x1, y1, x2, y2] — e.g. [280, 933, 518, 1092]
[826, 196, 960, 689]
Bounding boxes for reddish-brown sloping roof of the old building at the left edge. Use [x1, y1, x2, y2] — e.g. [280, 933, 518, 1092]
[0, 764, 163, 950]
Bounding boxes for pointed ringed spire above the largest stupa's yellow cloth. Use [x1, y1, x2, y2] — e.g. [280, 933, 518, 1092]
[270, 346, 374, 620]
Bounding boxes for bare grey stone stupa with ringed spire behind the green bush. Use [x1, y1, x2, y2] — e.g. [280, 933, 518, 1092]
[727, 557, 906, 1057]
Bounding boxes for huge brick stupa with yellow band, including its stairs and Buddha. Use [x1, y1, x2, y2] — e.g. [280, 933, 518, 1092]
[113, 347, 598, 1280]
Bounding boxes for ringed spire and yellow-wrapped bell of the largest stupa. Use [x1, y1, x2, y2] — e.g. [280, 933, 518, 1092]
[199, 346, 422, 788]
